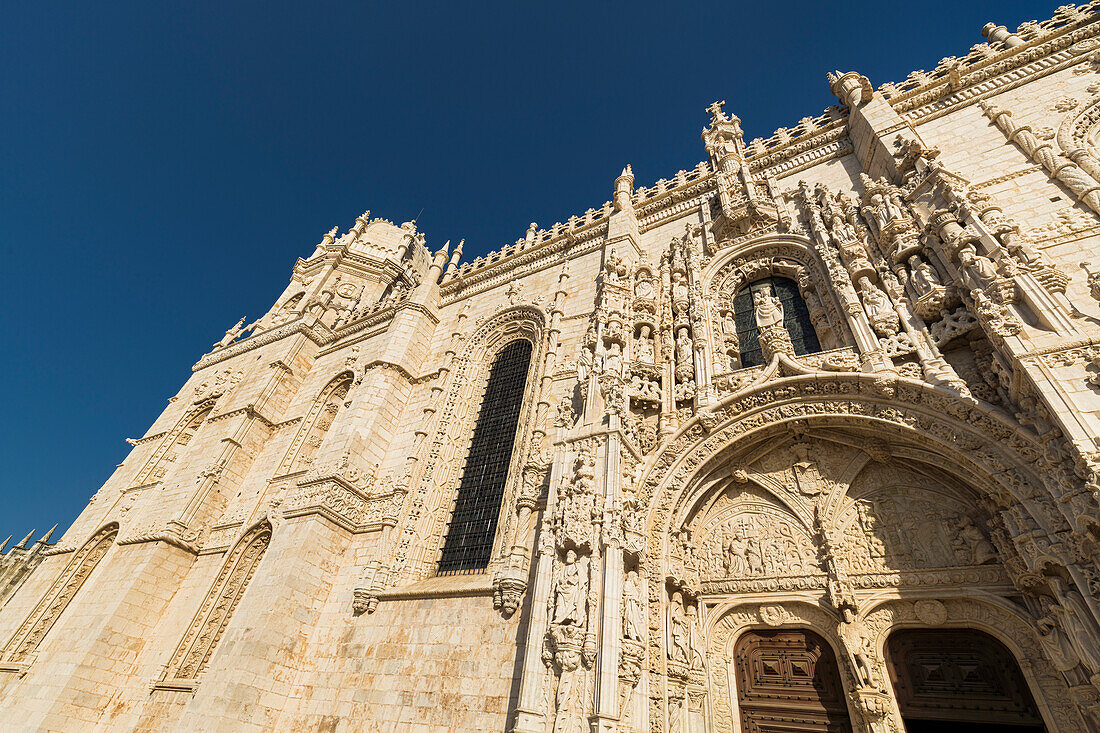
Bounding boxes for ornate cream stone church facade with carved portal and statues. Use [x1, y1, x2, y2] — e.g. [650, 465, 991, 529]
[0, 3, 1100, 733]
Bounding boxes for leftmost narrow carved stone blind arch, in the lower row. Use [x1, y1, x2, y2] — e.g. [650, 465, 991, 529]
[3, 523, 119, 664]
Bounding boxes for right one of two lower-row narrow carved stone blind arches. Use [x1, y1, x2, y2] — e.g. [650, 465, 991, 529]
[165, 522, 272, 679]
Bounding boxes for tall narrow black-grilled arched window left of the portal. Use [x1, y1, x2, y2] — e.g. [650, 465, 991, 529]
[438, 340, 531, 576]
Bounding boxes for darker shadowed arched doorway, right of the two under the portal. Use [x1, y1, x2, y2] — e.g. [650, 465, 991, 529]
[887, 628, 1045, 733]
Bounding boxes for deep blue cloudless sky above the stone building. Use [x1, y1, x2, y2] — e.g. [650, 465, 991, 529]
[0, 0, 1059, 540]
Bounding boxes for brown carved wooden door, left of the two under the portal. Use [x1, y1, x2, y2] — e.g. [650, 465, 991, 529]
[734, 628, 851, 733]
